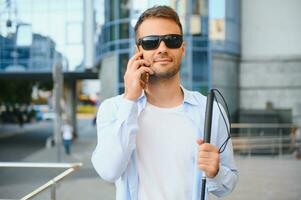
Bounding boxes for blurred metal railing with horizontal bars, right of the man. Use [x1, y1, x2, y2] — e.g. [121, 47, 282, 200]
[231, 123, 296, 157]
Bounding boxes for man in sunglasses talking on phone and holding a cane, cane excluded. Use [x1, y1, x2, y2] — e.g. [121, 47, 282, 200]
[92, 6, 238, 200]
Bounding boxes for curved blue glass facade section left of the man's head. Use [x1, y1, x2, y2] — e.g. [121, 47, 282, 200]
[96, 0, 130, 93]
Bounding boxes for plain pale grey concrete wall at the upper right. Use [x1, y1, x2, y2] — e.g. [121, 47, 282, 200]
[239, 0, 301, 110]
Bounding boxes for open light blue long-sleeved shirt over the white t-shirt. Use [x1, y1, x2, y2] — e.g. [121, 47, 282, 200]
[92, 87, 238, 200]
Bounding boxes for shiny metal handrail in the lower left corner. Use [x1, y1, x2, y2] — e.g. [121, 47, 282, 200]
[0, 162, 82, 200]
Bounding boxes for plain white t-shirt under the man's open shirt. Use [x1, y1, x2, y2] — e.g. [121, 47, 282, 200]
[136, 103, 197, 200]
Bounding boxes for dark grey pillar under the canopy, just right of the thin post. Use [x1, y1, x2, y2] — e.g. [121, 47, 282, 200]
[65, 80, 77, 137]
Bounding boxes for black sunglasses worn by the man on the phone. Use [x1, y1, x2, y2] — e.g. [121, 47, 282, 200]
[137, 34, 183, 50]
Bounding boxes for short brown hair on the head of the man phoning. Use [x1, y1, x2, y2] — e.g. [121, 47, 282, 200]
[135, 6, 183, 37]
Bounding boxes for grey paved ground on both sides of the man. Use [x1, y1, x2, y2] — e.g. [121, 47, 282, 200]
[0, 119, 301, 200]
